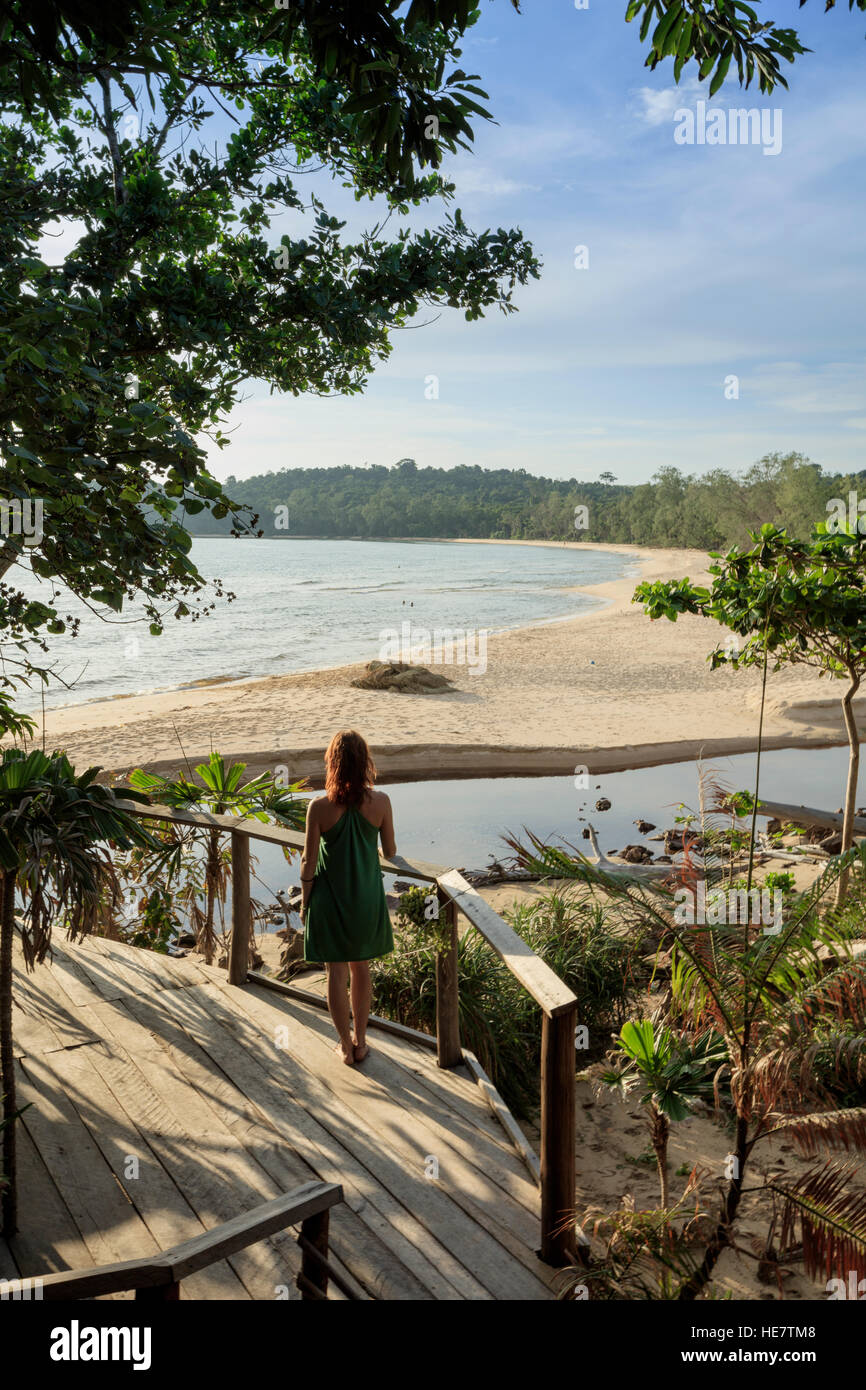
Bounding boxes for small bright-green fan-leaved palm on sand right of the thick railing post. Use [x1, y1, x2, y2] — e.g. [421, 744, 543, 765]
[599, 1019, 727, 1211]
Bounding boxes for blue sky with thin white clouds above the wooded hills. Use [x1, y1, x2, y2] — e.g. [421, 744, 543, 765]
[211, 0, 866, 482]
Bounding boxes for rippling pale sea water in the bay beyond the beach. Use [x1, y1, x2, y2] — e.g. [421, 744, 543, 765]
[21, 538, 637, 708]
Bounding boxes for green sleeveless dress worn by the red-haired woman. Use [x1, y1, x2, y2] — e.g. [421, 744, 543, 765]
[304, 806, 393, 960]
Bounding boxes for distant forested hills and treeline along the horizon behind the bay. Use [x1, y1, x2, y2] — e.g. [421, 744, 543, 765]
[190, 453, 866, 550]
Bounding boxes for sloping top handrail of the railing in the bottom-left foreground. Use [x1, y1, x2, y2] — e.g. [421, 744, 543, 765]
[4, 1182, 343, 1300]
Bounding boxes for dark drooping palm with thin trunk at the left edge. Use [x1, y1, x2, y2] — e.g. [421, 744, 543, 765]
[0, 748, 156, 1236]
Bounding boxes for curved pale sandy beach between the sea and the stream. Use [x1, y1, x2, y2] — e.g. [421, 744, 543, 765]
[38, 541, 861, 781]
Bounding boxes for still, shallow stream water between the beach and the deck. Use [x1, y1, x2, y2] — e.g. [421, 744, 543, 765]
[246, 748, 866, 898]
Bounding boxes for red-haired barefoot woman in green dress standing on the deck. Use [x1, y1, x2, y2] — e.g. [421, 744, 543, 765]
[300, 730, 396, 1066]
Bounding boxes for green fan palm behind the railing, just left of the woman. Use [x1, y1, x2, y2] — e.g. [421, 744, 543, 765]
[129, 752, 307, 965]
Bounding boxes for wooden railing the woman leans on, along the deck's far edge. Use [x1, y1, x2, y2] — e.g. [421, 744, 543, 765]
[111, 802, 577, 1265]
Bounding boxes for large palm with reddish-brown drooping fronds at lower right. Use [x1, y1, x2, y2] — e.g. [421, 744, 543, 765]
[507, 833, 866, 1300]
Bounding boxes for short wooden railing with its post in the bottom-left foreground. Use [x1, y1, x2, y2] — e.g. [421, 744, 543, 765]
[3, 1182, 347, 1302]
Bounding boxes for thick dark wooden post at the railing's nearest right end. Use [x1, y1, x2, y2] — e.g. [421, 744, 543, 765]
[541, 1004, 577, 1266]
